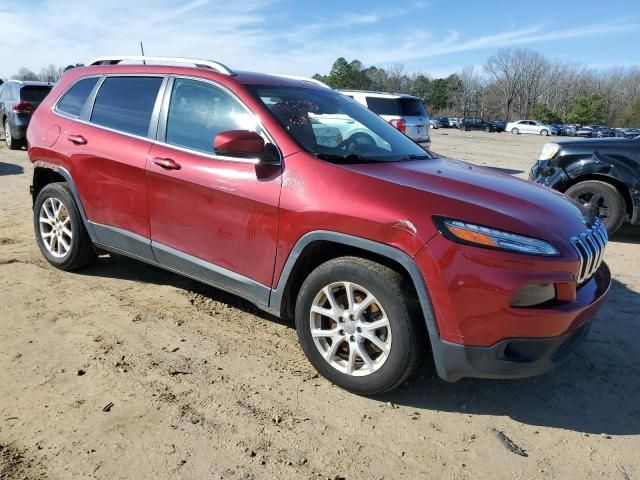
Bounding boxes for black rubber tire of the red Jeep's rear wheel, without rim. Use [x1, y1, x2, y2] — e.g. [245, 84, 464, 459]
[33, 182, 97, 271]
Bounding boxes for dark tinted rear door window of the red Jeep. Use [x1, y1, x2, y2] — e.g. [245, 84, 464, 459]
[91, 77, 162, 136]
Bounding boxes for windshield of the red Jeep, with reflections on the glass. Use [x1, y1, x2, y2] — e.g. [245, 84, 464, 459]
[247, 85, 434, 163]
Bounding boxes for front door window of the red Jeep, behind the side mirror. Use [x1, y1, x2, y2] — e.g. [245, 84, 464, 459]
[166, 78, 257, 153]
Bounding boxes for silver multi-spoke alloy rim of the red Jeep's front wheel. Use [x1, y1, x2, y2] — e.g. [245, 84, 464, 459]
[309, 282, 391, 376]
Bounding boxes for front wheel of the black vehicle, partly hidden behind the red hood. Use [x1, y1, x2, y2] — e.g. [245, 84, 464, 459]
[565, 180, 627, 235]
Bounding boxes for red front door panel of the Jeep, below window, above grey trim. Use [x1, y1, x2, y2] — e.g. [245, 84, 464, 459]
[148, 145, 282, 286]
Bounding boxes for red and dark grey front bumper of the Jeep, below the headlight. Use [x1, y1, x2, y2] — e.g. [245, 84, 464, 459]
[416, 237, 611, 382]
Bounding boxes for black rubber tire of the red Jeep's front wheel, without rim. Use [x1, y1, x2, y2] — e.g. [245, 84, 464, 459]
[295, 257, 428, 395]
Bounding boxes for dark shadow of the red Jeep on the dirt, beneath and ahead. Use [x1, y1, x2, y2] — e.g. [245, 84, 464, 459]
[75, 255, 640, 435]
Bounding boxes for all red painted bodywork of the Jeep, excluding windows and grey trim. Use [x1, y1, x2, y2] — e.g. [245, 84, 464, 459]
[28, 65, 610, 360]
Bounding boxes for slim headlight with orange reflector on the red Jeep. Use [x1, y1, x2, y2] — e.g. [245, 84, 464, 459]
[434, 217, 560, 257]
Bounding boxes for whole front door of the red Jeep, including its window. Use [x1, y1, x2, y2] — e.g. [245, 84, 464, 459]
[147, 77, 281, 296]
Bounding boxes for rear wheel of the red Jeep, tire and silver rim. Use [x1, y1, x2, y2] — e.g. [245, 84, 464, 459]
[33, 183, 97, 271]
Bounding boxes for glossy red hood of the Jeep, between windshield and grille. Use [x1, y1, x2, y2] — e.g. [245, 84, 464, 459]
[345, 158, 588, 252]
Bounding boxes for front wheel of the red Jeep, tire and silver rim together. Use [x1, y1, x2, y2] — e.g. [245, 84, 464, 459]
[295, 257, 426, 395]
